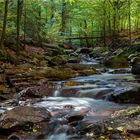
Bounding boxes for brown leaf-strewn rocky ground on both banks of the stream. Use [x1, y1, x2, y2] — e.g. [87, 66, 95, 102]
[0, 33, 140, 140]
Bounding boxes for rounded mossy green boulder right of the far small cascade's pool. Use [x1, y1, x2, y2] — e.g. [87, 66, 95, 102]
[104, 56, 129, 67]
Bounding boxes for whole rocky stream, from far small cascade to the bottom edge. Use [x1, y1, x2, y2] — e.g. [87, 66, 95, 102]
[1, 57, 140, 140]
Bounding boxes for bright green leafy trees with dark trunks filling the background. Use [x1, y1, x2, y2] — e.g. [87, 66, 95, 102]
[0, 0, 140, 50]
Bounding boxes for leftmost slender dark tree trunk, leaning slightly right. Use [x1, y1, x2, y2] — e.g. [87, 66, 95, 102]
[0, 0, 9, 49]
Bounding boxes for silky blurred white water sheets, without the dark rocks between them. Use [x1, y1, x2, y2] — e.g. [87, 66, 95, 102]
[34, 58, 139, 140]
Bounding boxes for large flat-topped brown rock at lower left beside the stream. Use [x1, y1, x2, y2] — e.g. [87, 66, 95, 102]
[0, 106, 51, 129]
